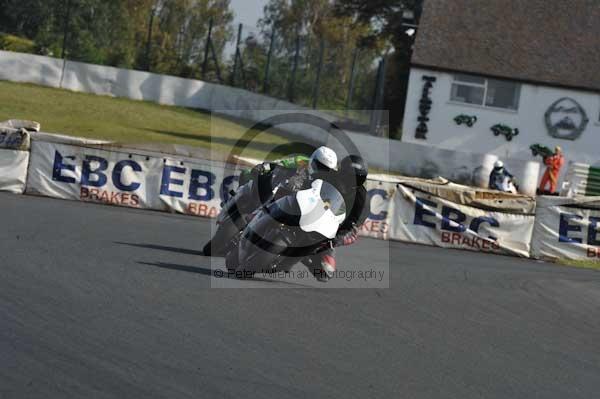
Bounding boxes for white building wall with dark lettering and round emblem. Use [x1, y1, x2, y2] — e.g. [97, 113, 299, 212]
[402, 68, 600, 170]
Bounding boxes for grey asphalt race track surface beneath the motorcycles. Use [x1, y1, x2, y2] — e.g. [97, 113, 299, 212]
[0, 194, 600, 399]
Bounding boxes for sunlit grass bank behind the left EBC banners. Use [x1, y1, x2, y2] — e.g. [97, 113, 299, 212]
[0, 81, 289, 159]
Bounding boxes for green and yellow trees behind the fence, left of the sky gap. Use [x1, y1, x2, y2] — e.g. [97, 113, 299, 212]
[0, 0, 233, 77]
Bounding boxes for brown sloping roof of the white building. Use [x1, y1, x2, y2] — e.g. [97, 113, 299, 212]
[412, 0, 600, 91]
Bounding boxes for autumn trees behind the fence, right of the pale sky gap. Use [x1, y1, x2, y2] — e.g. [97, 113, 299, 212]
[254, 0, 373, 109]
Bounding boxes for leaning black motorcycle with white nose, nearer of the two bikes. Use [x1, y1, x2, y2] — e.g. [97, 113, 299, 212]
[224, 179, 346, 273]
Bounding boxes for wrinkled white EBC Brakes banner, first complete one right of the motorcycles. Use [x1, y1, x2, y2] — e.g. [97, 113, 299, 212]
[389, 184, 534, 257]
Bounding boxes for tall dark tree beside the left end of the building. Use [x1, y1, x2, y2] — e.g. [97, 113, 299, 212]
[336, 0, 423, 138]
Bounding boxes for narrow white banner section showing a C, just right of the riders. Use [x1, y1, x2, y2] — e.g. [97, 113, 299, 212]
[360, 180, 396, 240]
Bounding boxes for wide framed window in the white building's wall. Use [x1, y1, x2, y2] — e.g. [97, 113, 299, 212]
[450, 75, 521, 110]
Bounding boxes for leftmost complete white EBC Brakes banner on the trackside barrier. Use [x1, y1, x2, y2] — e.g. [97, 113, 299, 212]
[27, 141, 165, 210]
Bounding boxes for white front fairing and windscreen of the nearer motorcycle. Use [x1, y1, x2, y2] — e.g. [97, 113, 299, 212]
[296, 180, 346, 239]
